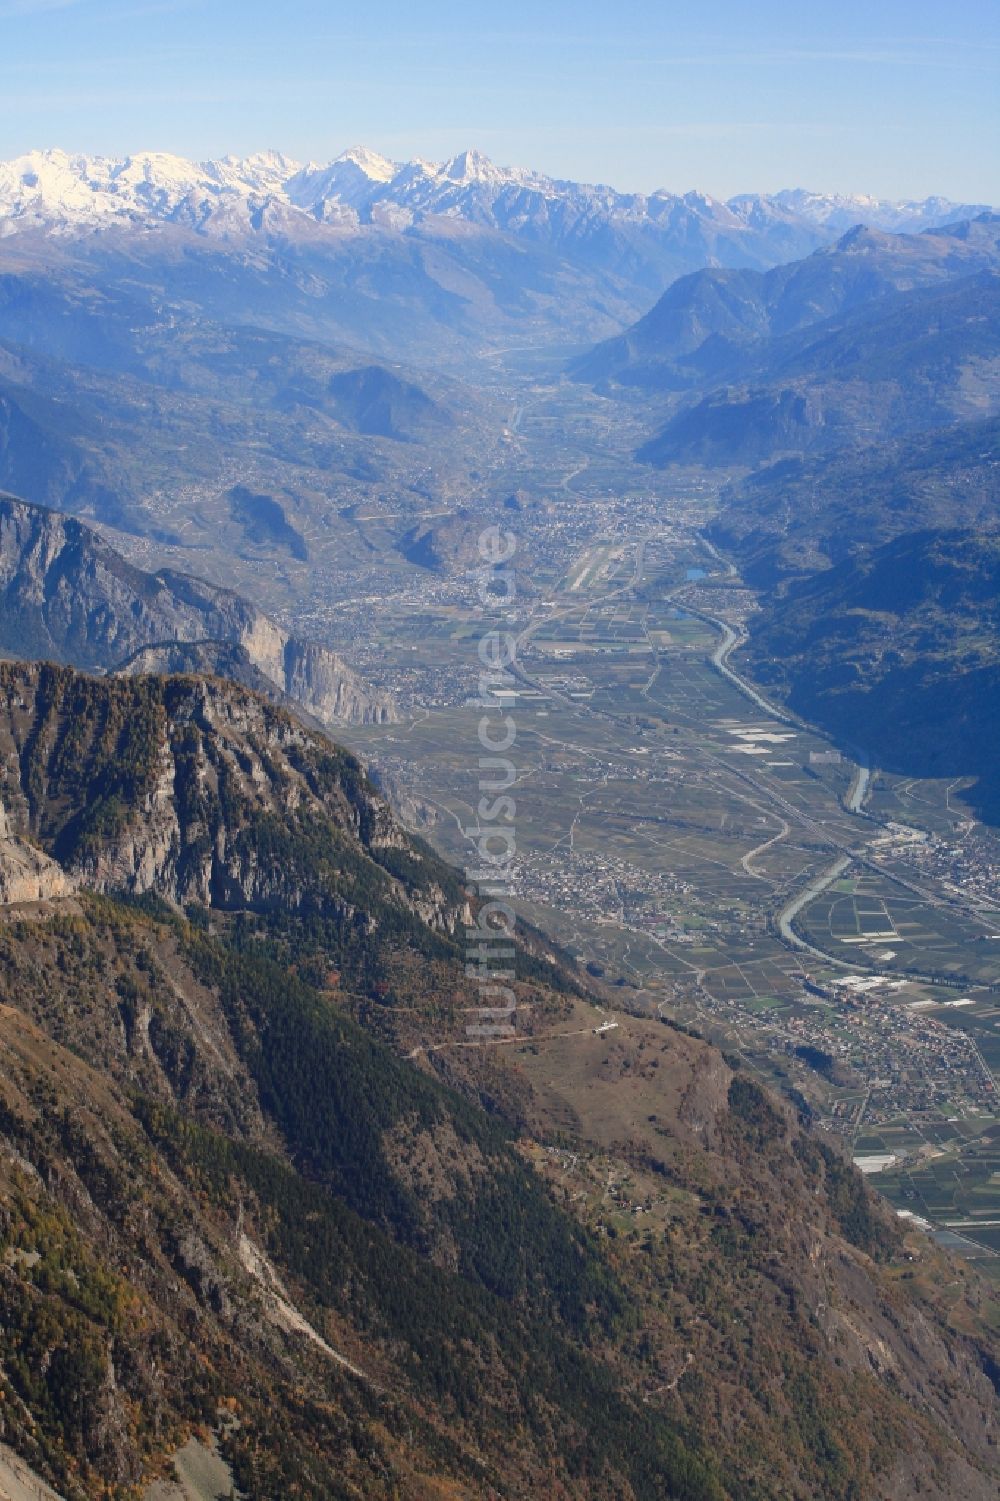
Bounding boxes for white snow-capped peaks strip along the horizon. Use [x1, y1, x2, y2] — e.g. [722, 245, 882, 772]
[0, 146, 982, 253]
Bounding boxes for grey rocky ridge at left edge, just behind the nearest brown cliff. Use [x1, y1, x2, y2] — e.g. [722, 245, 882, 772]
[0, 495, 393, 723]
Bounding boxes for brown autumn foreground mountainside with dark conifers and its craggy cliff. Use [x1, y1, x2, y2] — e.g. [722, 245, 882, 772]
[0, 665, 997, 1501]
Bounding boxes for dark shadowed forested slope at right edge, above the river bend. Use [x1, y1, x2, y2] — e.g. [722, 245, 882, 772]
[732, 531, 1000, 820]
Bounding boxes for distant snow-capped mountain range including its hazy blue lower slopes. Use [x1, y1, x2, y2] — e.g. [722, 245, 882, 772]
[0, 147, 974, 360]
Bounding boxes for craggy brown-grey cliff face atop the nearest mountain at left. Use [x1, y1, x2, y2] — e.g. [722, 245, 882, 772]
[0, 663, 456, 932]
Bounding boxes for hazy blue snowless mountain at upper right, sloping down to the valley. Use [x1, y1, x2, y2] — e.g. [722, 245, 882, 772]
[572, 215, 1000, 467]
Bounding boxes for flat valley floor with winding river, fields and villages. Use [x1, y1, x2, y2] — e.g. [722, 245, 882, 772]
[339, 474, 1000, 1274]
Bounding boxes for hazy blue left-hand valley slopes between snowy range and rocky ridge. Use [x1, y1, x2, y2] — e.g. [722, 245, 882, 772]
[0, 288, 488, 564]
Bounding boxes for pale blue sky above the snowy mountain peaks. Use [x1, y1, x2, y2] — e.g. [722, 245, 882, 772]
[0, 0, 1000, 203]
